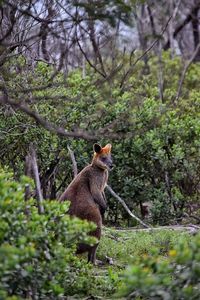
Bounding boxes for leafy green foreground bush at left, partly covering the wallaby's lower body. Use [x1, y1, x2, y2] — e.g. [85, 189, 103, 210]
[0, 172, 95, 299]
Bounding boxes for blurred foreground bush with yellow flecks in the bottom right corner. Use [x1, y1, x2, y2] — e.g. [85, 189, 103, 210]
[117, 235, 200, 300]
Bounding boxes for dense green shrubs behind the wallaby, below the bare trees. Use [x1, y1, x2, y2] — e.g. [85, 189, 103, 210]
[0, 53, 200, 224]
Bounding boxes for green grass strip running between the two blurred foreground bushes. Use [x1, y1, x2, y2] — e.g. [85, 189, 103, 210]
[85, 227, 195, 299]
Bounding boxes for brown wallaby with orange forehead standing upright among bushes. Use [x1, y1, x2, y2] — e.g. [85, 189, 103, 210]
[59, 144, 113, 264]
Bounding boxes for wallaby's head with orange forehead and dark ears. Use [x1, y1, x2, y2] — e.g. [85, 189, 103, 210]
[92, 144, 113, 170]
